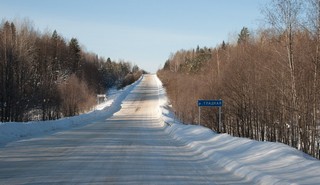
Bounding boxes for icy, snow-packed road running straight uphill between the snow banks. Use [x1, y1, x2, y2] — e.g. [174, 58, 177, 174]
[0, 75, 252, 185]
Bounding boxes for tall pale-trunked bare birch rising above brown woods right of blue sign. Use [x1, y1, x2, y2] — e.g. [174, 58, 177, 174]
[265, 0, 302, 146]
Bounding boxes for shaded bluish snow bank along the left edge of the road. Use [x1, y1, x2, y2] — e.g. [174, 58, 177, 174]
[0, 76, 143, 146]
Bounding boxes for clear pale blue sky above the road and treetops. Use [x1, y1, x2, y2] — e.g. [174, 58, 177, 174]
[0, 0, 268, 72]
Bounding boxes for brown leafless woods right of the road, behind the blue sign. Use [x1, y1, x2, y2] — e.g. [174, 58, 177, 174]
[158, 0, 320, 158]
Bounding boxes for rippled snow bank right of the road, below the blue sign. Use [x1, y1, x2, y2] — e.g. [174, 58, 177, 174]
[156, 74, 320, 185]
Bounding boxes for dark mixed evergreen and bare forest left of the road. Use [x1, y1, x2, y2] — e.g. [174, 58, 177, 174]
[0, 20, 142, 122]
